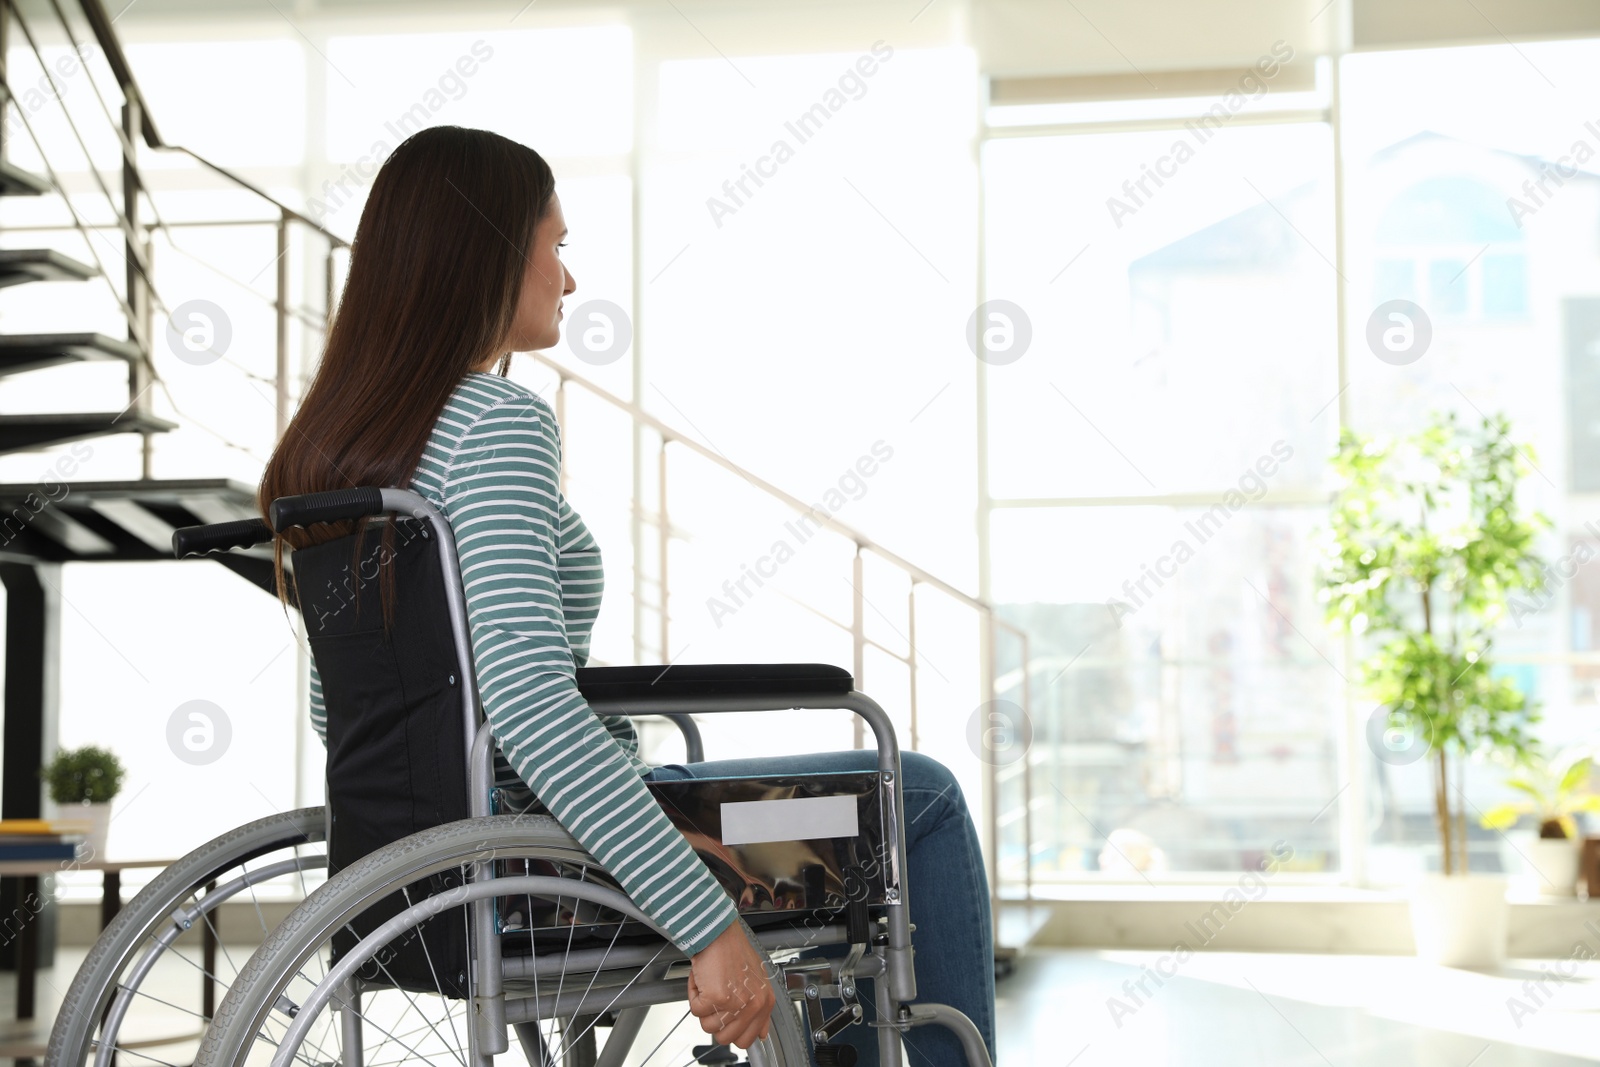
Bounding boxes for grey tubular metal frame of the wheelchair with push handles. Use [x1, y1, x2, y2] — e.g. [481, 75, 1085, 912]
[159, 488, 990, 1067]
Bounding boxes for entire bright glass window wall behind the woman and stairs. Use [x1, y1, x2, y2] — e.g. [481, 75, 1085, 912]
[21, 6, 1600, 886]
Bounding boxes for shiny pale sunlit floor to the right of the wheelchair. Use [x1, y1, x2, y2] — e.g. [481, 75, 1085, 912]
[997, 949, 1600, 1067]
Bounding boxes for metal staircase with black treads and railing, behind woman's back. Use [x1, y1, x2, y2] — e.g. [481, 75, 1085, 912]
[0, 0, 346, 601]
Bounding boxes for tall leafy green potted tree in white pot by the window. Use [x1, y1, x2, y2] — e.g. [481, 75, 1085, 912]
[1322, 413, 1549, 966]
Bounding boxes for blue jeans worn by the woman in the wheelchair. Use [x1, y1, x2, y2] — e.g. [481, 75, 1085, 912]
[650, 749, 995, 1067]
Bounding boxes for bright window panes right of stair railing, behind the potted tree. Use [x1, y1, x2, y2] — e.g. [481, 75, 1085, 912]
[984, 42, 1600, 888]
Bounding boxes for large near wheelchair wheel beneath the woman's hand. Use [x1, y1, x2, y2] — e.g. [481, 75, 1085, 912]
[195, 816, 810, 1067]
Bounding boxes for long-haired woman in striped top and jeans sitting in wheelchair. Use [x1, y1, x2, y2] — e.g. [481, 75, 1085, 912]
[259, 126, 994, 1065]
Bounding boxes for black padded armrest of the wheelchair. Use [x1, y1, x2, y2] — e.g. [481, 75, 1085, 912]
[578, 664, 856, 701]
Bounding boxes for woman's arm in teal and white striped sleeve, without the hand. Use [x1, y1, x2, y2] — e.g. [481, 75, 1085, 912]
[443, 397, 738, 955]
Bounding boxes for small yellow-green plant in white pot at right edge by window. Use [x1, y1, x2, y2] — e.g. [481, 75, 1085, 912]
[1480, 753, 1600, 896]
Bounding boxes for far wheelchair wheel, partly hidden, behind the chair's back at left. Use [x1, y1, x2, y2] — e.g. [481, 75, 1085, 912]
[45, 808, 326, 1067]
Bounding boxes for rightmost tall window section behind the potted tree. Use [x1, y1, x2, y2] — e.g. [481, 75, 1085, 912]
[1344, 40, 1600, 883]
